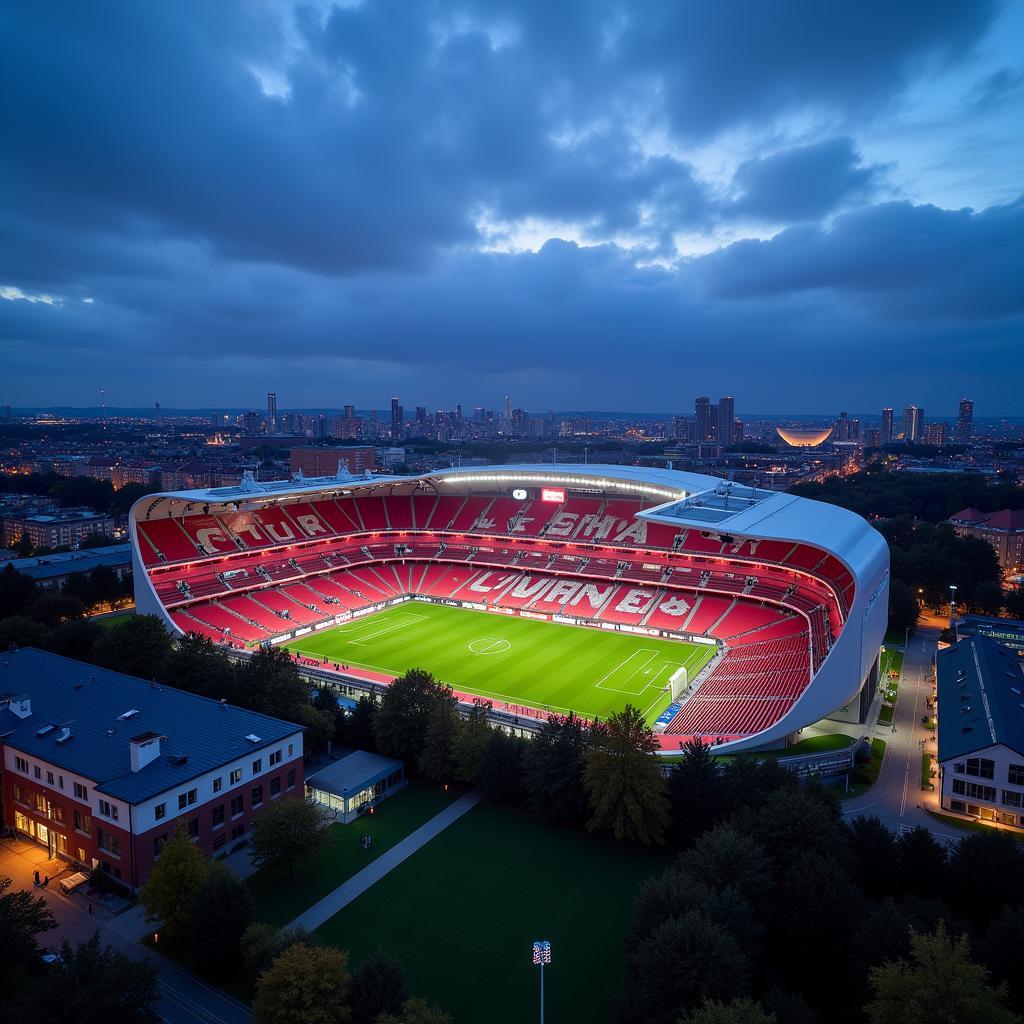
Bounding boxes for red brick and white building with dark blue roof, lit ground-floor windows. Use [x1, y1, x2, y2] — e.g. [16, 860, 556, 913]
[0, 648, 303, 890]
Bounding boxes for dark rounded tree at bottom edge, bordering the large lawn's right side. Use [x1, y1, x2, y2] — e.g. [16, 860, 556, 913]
[621, 911, 749, 1024]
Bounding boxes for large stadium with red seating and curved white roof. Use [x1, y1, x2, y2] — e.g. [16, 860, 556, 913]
[130, 465, 889, 753]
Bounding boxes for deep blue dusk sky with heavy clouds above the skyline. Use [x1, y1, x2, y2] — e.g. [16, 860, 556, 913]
[0, 0, 1024, 415]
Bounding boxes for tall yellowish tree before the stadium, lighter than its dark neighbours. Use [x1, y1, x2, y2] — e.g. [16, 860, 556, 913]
[584, 705, 670, 843]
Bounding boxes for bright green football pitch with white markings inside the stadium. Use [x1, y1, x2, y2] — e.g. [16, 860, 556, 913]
[286, 601, 715, 722]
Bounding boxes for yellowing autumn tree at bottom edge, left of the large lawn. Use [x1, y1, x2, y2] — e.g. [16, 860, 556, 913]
[253, 944, 351, 1024]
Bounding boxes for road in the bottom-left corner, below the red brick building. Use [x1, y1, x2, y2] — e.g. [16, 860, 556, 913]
[0, 840, 251, 1024]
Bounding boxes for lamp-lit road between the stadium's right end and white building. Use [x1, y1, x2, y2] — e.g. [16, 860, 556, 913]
[843, 626, 964, 843]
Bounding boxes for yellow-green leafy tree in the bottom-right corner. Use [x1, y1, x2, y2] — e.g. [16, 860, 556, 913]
[864, 922, 1021, 1024]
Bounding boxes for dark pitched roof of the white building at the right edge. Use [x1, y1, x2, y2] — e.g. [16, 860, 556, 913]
[936, 636, 1024, 761]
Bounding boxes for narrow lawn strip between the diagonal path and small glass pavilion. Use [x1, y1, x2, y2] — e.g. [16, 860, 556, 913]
[249, 779, 464, 925]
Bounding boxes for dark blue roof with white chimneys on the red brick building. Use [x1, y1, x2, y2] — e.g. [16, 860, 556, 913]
[0, 648, 302, 804]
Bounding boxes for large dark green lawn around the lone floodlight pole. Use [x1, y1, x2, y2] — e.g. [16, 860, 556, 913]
[316, 804, 672, 1024]
